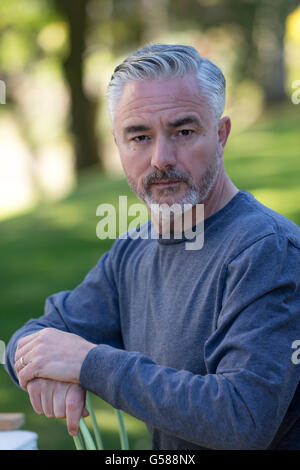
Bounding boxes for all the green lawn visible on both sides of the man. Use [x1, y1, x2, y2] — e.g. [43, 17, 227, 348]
[0, 105, 300, 449]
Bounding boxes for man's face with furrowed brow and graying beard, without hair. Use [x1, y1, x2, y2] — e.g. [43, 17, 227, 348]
[113, 75, 229, 211]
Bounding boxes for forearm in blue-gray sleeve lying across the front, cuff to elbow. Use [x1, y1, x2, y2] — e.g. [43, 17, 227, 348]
[80, 346, 290, 449]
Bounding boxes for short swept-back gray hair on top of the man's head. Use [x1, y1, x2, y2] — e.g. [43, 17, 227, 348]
[106, 44, 225, 122]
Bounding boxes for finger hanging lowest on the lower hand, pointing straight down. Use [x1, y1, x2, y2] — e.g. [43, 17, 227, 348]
[66, 384, 85, 436]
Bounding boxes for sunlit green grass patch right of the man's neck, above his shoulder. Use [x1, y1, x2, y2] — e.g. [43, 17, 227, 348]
[225, 104, 300, 225]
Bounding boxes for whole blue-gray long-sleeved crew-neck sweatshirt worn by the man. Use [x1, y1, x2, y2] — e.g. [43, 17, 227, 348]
[6, 191, 300, 450]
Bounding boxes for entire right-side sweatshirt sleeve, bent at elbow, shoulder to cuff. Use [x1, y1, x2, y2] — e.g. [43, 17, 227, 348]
[80, 234, 300, 449]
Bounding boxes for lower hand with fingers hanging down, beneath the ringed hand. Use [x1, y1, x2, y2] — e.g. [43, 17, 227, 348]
[27, 379, 89, 436]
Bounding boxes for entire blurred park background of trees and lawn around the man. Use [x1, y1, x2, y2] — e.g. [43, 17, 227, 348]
[0, 0, 300, 449]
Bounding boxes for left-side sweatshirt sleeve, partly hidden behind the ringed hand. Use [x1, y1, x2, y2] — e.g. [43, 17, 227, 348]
[5, 244, 123, 385]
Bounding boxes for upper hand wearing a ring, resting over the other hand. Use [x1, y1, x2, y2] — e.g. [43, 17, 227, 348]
[15, 328, 97, 391]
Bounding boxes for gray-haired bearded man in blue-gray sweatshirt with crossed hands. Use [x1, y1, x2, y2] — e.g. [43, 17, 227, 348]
[7, 45, 300, 450]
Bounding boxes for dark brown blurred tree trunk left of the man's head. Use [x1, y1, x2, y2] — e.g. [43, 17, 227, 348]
[56, 0, 103, 171]
